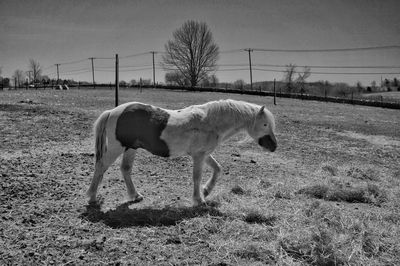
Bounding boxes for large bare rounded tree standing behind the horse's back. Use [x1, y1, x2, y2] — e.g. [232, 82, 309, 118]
[163, 20, 219, 87]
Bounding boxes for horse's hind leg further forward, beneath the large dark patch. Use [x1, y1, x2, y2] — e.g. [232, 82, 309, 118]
[121, 149, 143, 202]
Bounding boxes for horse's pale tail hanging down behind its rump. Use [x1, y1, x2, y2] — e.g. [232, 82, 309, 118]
[93, 111, 110, 162]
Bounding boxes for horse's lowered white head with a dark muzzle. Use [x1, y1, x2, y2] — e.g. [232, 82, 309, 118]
[249, 106, 277, 152]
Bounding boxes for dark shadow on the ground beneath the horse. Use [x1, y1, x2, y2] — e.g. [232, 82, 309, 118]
[80, 202, 226, 228]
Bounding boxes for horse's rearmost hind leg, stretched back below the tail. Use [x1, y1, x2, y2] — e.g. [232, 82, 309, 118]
[86, 148, 123, 203]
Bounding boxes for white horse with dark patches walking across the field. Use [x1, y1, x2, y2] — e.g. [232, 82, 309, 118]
[87, 99, 277, 206]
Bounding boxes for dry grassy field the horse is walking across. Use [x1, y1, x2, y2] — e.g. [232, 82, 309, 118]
[0, 90, 400, 265]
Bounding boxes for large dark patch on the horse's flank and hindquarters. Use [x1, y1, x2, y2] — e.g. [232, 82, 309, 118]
[115, 103, 170, 157]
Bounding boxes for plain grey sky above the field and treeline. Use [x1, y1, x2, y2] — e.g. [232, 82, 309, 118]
[0, 0, 400, 85]
